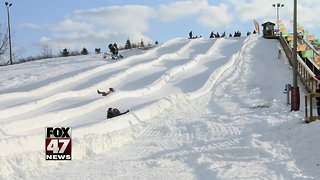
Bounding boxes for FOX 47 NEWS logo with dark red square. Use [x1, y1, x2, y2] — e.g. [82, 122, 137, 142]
[45, 127, 71, 160]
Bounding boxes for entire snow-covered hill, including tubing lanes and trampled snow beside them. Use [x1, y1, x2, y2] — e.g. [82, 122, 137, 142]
[0, 35, 320, 179]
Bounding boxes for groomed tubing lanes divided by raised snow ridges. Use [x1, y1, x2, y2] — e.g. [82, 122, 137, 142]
[0, 35, 272, 179]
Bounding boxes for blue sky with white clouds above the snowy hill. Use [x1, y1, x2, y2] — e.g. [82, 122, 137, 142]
[0, 0, 320, 57]
